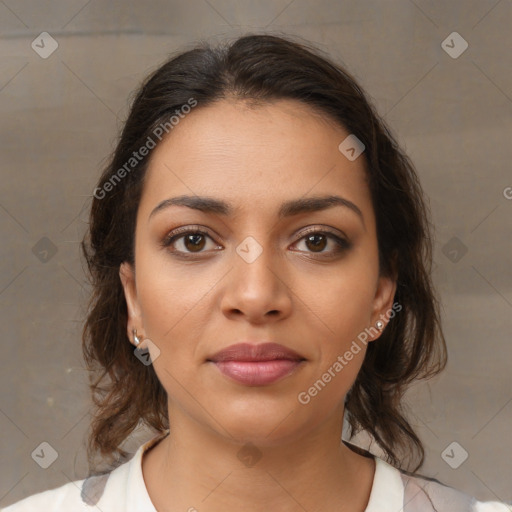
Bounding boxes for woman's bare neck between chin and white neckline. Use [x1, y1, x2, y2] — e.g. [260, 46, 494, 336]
[142, 411, 375, 512]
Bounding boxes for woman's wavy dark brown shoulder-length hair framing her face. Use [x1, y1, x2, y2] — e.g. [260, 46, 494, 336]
[81, 35, 447, 471]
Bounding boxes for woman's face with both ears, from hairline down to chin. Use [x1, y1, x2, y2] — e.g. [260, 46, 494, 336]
[120, 100, 395, 445]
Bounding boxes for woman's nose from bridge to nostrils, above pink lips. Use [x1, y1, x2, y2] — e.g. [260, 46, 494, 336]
[221, 242, 293, 324]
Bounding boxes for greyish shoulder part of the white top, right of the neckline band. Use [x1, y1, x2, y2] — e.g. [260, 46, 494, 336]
[396, 464, 512, 512]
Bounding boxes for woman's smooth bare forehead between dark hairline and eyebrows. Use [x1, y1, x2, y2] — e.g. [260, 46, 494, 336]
[140, 100, 372, 226]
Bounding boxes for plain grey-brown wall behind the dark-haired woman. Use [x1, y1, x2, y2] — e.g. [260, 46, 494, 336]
[0, 0, 512, 506]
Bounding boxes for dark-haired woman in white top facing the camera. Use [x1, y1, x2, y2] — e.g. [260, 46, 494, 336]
[6, 35, 510, 512]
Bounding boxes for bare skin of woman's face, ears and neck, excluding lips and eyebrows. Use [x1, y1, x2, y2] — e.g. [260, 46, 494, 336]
[120, 99, 396, 512]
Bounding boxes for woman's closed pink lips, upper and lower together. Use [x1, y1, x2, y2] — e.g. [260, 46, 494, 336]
[208, 343, 305, 386]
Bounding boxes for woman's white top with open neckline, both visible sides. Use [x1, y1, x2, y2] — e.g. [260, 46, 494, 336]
[2, 431, 512, 512]
